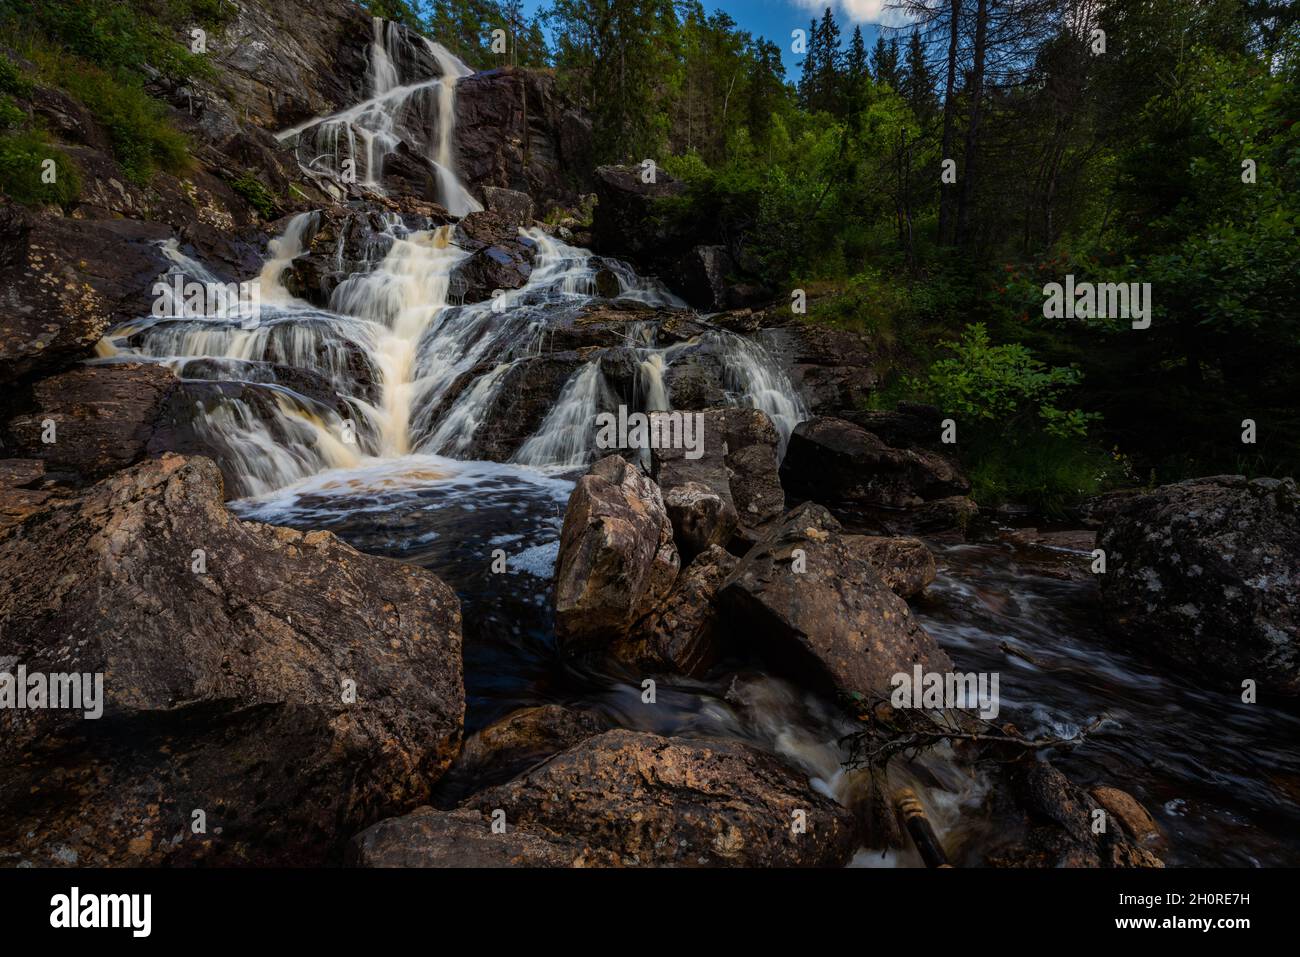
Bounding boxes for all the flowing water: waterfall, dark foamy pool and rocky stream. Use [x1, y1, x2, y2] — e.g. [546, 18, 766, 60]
[99, 14, 1300, 866]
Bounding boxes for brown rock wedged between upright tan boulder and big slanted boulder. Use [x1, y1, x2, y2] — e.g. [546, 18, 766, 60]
[612, 545, 738, 677]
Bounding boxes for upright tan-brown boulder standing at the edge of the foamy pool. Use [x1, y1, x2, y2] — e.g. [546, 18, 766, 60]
[555, 455, 679, 651]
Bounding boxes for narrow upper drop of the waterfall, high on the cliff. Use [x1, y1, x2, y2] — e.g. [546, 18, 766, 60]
[277, 17, 482, 216]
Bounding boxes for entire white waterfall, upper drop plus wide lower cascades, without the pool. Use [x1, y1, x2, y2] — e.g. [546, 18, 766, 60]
[94, 20, 807, 495]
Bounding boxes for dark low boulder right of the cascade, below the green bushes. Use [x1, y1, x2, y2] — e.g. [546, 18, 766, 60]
[781, 416, 970, 508]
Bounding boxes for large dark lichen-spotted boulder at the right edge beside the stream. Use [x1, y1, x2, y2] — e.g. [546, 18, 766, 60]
[1097, 476, 1300, 694]
